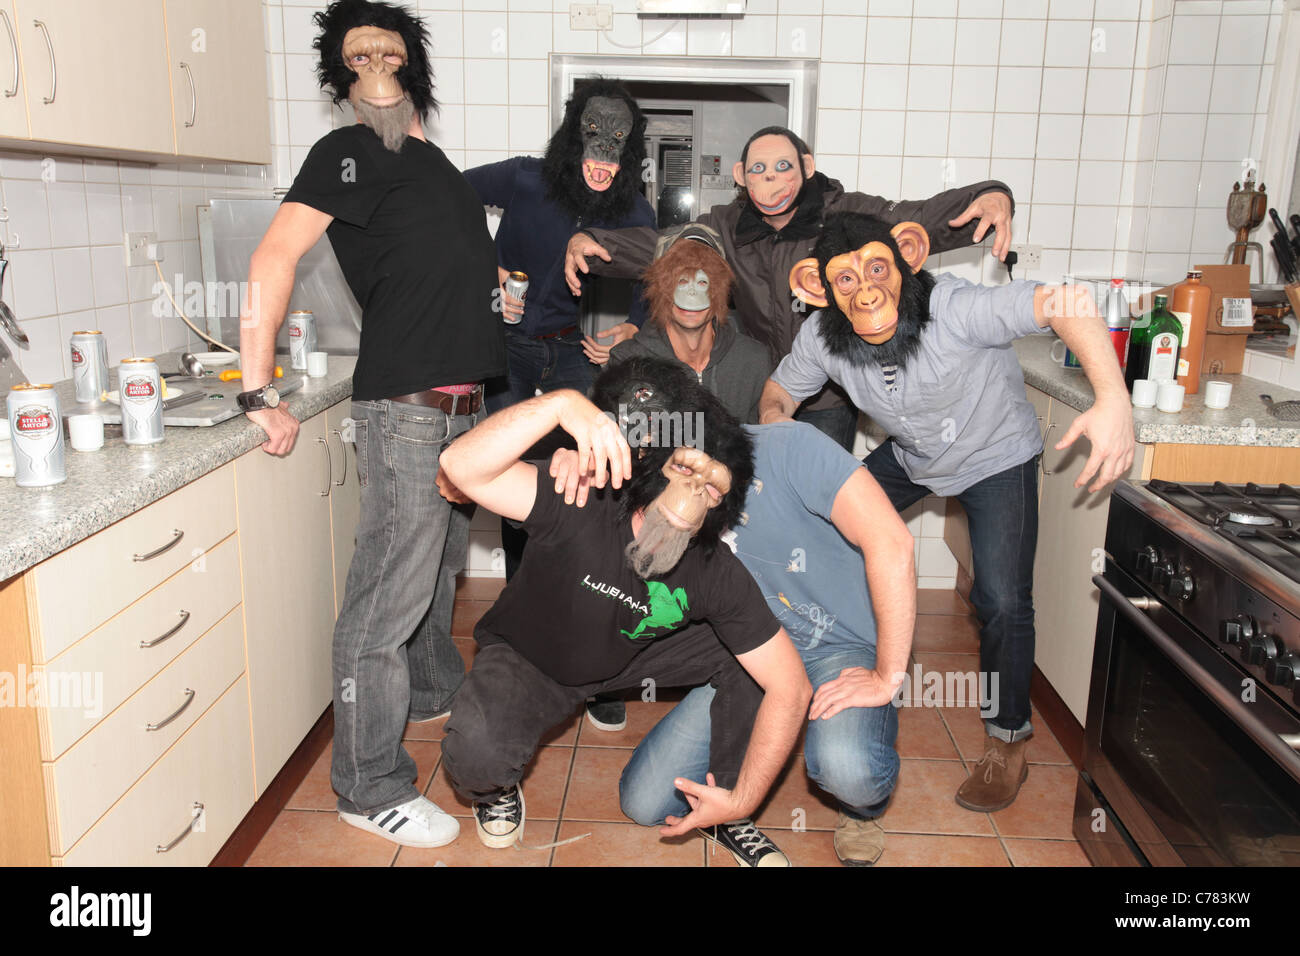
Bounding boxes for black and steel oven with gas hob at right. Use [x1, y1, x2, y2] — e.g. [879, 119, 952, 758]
[1074, 483, 1300, 866]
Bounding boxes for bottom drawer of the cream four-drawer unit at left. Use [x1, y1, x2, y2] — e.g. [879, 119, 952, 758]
[55, 678, 252, 866]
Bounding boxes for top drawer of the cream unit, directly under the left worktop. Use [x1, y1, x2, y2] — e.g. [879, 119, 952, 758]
[31, 466, 235, 662]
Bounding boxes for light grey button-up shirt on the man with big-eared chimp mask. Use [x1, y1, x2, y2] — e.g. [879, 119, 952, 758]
[772, 274, 1043, 496]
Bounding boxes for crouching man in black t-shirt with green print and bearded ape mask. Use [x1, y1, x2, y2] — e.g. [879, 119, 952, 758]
[438, 359, 811, 866]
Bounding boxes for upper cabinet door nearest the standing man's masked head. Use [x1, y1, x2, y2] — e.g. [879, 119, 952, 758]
[165, 0, 271, 164]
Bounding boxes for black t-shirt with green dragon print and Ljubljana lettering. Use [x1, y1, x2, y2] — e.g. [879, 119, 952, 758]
[475, 464, 781, 687]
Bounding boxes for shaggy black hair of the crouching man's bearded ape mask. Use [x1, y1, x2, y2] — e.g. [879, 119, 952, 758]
[592, 358, 754, 551]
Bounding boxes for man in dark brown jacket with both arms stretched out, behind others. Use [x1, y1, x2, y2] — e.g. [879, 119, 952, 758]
[564, 126, 1014, 451]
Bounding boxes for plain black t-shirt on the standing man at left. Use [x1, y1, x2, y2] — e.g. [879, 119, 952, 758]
[285, 124, 506, 399]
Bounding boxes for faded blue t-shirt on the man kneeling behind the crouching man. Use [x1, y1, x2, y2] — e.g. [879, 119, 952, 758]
[723, 421, 876, 661]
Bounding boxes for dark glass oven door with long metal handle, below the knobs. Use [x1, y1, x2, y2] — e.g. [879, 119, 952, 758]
[1075, 561, 1300, 866]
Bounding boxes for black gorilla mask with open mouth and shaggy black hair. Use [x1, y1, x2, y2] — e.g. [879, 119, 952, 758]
[542, 78, 646, 222]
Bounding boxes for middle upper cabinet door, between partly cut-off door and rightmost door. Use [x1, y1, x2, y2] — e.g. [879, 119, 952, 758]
[14, 0, 176, 153]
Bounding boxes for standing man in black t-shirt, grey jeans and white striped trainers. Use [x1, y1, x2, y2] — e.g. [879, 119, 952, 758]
[239, 0, 504, 847]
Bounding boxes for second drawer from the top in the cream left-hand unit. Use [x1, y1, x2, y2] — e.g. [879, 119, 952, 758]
[40, 535, 239, 760]
